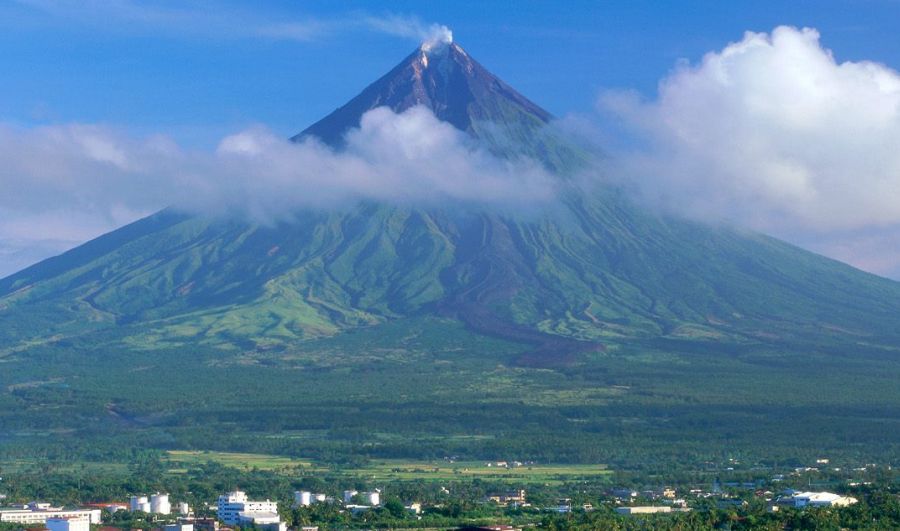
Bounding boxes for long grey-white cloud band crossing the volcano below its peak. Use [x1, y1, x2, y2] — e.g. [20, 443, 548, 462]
[0, 107, 555, 275]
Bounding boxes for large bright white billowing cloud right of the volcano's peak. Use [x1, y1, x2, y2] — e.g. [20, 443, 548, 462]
[599, 26, 900, 274]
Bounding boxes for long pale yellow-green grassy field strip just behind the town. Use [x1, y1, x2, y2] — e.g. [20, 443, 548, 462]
[167, 450, 611, 483]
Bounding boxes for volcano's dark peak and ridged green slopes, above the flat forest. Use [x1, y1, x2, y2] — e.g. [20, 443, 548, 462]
[0, 43, 900, 366]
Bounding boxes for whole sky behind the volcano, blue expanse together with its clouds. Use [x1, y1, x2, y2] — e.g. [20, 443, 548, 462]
[0, 0, 900, 279]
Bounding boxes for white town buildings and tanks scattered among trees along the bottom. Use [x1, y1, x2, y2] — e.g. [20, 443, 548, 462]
[0, 478, 857, 531]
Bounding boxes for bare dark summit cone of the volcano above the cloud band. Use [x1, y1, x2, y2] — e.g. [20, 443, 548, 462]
[293, 41, 551, 147]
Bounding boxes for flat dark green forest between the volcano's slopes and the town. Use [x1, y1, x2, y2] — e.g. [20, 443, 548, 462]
[0, 318, 900, 469]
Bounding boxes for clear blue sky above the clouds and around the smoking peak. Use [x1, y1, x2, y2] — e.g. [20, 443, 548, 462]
[0, 0, 900, 146]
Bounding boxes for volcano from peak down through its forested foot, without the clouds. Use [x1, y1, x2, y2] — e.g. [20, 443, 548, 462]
[0, 40, 900, 466]
